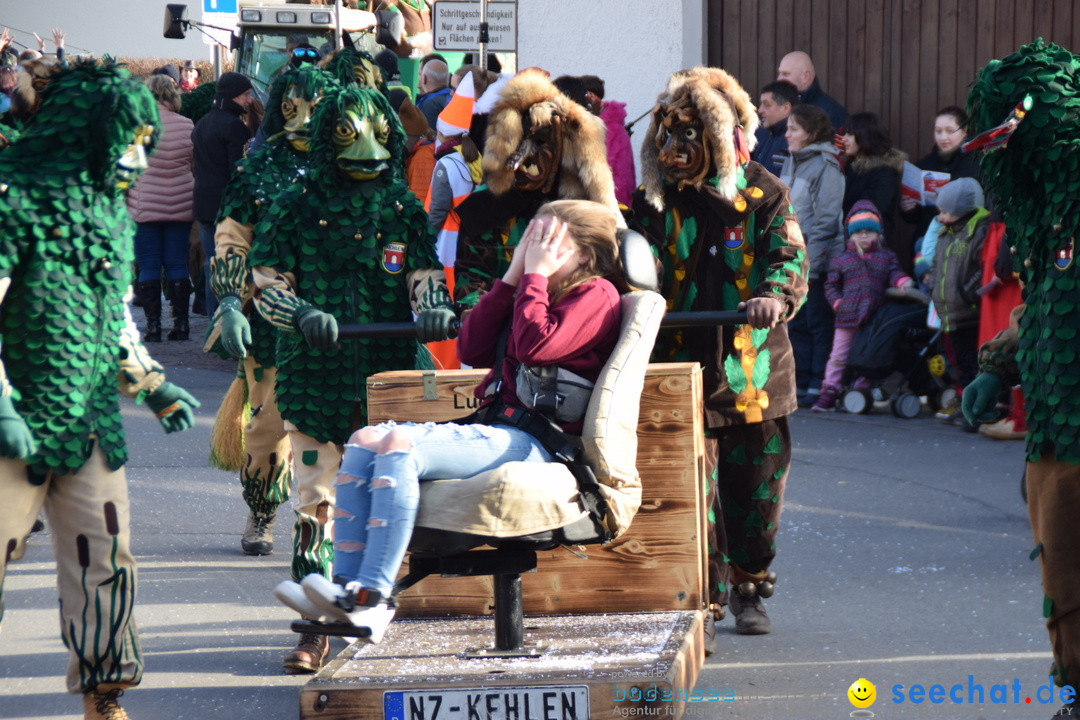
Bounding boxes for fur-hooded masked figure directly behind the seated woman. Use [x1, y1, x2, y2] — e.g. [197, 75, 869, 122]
[454, 68, 619, 308]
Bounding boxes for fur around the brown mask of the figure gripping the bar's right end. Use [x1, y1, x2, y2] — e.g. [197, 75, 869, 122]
[640, 67, 760, 209]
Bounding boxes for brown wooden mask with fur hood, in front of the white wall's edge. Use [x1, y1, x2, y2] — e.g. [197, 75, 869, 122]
[642, 67, 759, 208]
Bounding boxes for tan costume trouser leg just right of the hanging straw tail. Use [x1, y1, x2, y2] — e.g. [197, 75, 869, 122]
[240, 355, 293, 515]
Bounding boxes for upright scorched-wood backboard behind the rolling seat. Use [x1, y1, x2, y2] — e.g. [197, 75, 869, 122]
[367, 363, 708, 617]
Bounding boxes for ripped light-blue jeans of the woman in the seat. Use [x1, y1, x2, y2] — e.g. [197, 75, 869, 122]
[334, 422, 552, 594]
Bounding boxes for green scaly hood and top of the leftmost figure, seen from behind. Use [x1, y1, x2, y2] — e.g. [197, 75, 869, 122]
[0, 63, 160, 484]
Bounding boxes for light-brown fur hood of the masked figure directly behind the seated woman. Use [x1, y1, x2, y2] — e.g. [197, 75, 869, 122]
[484, 68, 619, 213]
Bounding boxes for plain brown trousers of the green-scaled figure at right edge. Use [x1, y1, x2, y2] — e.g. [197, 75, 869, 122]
[1027, 453, 1080, 688]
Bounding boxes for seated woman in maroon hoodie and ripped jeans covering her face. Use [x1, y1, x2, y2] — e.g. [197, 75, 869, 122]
[274, 200, 624, 642]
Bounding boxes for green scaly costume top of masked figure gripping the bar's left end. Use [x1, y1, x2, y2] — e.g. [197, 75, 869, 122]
[251, 174, 438, 444]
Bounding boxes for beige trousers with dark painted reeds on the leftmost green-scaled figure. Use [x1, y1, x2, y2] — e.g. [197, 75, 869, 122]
[0, 447, 143, 693]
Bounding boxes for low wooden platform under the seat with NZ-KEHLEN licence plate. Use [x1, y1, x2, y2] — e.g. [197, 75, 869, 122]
[300, 611, 704, 720]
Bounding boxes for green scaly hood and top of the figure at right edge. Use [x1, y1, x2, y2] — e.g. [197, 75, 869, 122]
[968, 40, 1080, 463]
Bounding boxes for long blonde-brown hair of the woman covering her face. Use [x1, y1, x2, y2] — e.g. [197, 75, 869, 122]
[536, 200, 629, 302]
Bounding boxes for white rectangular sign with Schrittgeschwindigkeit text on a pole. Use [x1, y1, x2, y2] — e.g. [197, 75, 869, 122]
[429, 0, 517, 53]
